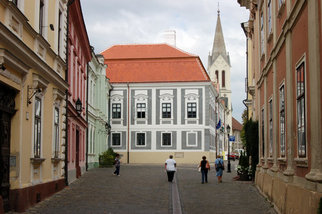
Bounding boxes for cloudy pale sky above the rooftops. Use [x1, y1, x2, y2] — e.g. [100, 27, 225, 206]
[81, 0, 249, 122]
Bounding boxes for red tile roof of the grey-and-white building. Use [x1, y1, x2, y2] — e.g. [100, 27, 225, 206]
[101, 44, 210, 83]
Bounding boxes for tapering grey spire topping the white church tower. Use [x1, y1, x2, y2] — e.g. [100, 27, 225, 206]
[208, 6, 230, 66]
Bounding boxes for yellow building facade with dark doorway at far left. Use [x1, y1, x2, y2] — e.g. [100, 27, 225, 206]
[0, 0, 68, 213]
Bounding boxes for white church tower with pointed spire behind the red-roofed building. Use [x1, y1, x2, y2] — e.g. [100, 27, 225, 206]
[208, 9, 232, 150]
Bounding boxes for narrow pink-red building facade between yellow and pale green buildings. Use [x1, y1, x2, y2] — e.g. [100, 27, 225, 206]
[67, 0, 91, 183]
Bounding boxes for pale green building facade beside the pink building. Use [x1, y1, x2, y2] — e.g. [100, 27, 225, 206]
[87, 52, 112, 168]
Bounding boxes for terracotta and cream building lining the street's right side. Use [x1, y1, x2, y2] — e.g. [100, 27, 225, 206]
[238, 0, 322, 214]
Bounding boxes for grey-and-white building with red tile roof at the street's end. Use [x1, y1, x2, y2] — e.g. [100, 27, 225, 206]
[101, 44, 218, 163]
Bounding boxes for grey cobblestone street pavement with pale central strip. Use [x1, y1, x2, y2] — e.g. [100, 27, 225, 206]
[20, 161, 275, 214]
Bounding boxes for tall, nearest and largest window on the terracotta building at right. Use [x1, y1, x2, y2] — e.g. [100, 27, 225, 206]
[296, 62, 306, 157]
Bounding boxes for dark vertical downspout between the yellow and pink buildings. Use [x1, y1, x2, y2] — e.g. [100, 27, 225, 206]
[64, 0, 75, 186]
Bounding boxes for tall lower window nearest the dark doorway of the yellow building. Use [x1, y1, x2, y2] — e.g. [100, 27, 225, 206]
[34, 97, 41, 158]
